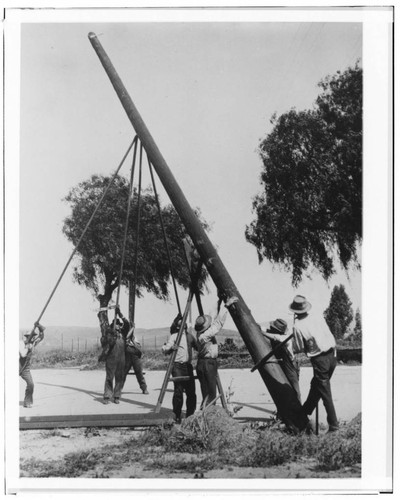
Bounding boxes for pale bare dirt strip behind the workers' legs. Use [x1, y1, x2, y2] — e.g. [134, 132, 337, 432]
[20, 366, 361, 422]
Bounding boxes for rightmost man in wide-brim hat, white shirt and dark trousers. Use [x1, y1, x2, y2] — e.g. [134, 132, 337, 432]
[289, 295, 339, 431]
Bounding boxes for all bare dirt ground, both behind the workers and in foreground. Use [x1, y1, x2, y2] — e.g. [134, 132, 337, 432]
[19, 366, 361, 479]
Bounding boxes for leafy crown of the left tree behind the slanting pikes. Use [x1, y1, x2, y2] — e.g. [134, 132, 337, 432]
[62, 175, 208, 330]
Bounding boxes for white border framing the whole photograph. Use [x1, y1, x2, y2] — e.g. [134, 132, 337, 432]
[4, 2, 393, 496]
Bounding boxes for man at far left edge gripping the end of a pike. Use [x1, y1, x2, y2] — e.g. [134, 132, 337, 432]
[19, 322, 45, 408]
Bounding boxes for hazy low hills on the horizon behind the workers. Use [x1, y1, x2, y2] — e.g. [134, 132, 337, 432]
[18, 326, 242, 351]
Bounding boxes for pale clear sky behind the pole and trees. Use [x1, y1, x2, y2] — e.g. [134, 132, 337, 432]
[19, 17, 363, 328]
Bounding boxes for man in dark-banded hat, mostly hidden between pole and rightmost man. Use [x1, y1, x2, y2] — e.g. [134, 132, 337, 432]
[263, 318, 301, 402]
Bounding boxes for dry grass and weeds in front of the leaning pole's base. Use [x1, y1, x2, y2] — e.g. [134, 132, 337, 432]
[135, 407, 361, 471]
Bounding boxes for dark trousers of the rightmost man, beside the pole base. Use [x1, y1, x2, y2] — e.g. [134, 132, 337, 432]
[303, 349, 339, 430]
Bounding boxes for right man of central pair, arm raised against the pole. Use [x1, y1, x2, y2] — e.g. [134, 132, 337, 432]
[194, 297, 238, 408]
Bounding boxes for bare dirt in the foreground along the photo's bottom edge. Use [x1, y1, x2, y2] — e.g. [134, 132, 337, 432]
[20, 428, 361, 479]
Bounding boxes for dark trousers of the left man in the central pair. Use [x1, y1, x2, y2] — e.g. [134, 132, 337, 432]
[172, 363, 197, 419]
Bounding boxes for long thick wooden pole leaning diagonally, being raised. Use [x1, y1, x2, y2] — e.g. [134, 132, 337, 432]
[88, 33, 308, 431]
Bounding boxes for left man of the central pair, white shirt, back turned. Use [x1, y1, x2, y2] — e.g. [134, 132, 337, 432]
[161, 314, 197, 424]
